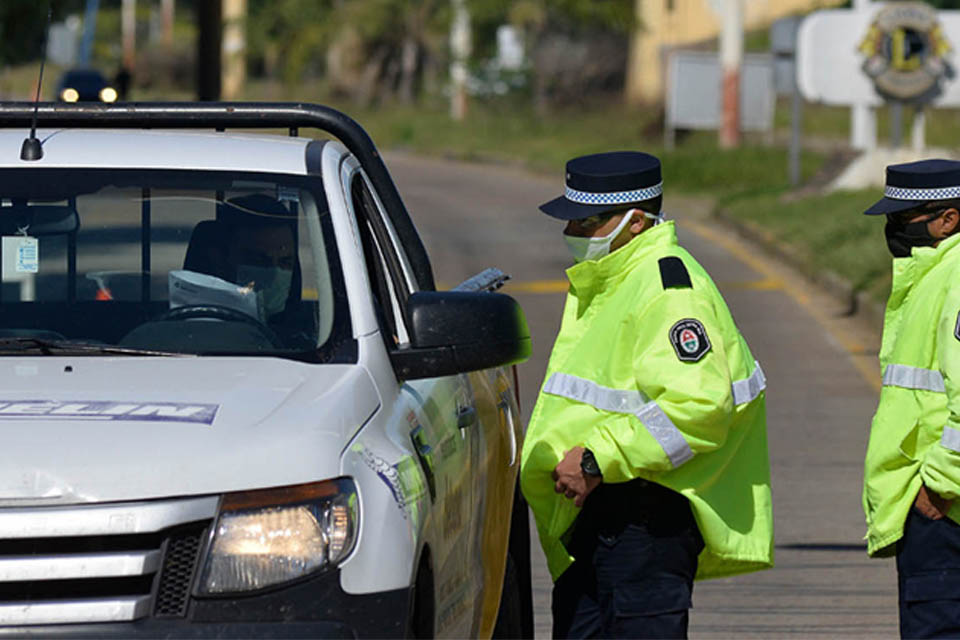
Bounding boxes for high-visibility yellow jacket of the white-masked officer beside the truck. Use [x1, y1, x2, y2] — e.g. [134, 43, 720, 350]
[521, 222, 773, 580]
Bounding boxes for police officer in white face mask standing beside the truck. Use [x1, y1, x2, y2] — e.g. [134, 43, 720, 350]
[521, 152, 773, 638]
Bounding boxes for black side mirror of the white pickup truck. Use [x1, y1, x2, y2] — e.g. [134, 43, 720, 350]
[390, 291, 530, 380]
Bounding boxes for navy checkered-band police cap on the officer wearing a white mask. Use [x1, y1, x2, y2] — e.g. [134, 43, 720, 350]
[540, 151, 663, 220]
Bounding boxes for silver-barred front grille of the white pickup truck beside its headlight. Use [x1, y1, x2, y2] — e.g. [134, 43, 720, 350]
[0, 497, 217, 625]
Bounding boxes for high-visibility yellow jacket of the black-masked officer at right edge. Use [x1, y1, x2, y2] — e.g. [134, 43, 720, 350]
[863, 235, 960, 556]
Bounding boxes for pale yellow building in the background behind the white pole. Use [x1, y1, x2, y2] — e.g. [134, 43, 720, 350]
[626, 0, 843, 104]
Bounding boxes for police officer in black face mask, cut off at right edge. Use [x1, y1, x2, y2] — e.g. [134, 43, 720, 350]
[863, 160, 960, 638]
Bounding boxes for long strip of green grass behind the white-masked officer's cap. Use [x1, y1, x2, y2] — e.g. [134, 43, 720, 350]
[332, 100, 823, 195]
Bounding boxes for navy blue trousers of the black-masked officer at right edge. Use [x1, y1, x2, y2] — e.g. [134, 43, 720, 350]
[897, 507, 960, 638]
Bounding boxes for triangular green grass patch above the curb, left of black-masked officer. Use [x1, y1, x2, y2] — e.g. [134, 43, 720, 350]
[720, 189, 891, 301]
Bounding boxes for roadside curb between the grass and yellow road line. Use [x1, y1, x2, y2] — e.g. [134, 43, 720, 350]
[710, 203, 884, 333]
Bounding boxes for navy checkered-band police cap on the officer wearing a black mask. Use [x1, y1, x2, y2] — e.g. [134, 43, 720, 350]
[864, 160, 960, 216]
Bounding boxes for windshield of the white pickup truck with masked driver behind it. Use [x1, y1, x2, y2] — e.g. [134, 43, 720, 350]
[0, 168, 356, 361]
